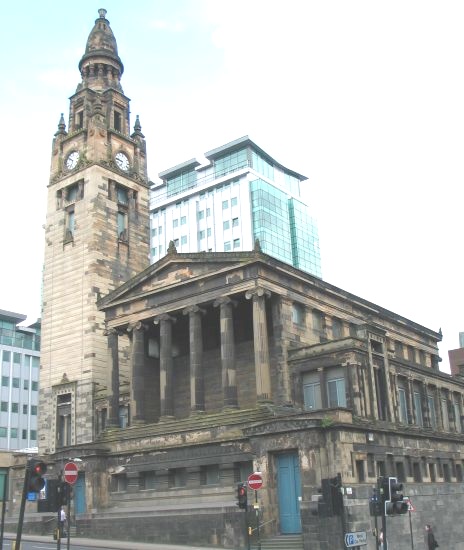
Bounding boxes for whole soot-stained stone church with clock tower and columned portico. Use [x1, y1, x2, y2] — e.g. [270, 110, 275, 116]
[26, 10, 464, 550]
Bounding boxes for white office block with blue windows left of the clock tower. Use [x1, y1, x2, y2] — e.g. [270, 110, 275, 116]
[0, 309, 40, 450]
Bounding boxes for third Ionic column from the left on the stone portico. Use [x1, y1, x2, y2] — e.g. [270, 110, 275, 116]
[154, 313, 175, 417]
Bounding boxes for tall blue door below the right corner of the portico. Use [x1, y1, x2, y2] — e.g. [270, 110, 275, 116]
[277, 453, 301, 535]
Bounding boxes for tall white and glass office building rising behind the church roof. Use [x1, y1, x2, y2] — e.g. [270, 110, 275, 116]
[150, 136, 321, 277]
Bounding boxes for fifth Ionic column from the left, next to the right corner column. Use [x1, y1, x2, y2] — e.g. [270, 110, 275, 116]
[214, 297, 238, 408]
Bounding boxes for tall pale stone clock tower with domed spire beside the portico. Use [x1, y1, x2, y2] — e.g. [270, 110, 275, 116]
[39, 9, 149, 453]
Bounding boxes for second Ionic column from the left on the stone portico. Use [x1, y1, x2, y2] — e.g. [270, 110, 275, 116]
[127, 321, 147, 423]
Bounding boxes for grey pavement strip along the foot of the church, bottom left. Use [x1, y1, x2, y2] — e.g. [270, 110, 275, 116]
[4, 533, 223, 550]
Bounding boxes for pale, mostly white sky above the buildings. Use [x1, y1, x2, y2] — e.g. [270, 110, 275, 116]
[0, 0, 464, 371]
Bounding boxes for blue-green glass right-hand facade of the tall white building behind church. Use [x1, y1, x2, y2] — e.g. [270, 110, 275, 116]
[250, 179, 321, 277]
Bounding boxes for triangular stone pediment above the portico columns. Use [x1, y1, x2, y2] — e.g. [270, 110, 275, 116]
[98, 252, 266, 309]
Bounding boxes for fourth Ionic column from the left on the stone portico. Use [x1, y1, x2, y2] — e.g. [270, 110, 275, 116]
[183, 306, 205, 412]
